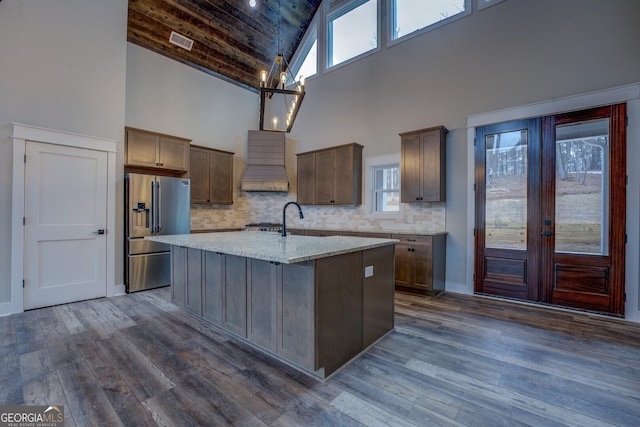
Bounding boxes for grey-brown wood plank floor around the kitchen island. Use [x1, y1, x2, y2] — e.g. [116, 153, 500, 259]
[0, 288, 640, 427]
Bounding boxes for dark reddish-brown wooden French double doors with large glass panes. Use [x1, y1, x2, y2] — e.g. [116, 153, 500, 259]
[474, 104, 626, 315]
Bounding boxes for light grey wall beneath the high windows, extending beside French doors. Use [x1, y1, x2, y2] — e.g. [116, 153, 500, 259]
[292, 0, 640, 314]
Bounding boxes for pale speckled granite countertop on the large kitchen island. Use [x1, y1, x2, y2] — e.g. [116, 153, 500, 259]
[145, 231, 398, 264]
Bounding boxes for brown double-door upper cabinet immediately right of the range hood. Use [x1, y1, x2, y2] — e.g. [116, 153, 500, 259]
[297, 143, 363, 206]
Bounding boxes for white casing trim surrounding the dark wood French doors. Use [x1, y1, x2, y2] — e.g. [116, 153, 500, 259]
[464, 82, 640, 322]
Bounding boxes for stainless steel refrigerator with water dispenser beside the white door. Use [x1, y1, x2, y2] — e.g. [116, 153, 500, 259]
[125, 173, 191, 292]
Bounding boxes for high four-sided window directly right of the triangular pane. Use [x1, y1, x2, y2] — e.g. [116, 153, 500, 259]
[327, 0, 378, 67]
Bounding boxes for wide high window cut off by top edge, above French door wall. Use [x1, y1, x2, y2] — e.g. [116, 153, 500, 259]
[391, 0, 470, 40]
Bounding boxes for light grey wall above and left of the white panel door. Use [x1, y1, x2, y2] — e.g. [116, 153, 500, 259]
[0, 0, 127, 303]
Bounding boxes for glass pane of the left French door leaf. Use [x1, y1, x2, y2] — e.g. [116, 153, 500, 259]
[484, 129, 528, 250]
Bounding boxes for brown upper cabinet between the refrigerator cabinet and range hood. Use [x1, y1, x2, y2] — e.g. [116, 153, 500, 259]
[189, 145, 234, 205]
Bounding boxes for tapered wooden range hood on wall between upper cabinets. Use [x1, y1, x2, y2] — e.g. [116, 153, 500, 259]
[240, 130, 289, 192]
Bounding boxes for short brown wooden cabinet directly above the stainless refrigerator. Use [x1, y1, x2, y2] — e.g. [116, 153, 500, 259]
[125, 128, 191, 172]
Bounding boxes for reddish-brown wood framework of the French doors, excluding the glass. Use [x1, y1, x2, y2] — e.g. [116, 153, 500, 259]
[474, 104, 626, 316]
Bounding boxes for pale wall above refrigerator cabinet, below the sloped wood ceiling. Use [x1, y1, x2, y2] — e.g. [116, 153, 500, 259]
[126, 43, 260, 158]
